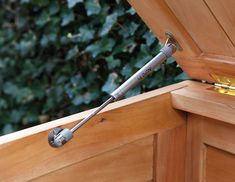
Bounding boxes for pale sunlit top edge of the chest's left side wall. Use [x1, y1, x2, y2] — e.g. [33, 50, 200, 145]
[0, 81, 191, 145]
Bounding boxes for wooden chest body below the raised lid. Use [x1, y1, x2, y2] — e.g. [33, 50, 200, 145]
[0, 81, 235, 182]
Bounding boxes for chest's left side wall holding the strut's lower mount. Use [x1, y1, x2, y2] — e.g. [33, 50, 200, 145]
[0, 82, 189, 181]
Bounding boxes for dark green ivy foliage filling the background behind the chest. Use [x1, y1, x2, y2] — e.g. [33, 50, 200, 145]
[0, 0, 184, 134]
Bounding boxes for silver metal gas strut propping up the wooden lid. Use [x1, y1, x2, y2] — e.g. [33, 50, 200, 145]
[48, 32, 182, 148]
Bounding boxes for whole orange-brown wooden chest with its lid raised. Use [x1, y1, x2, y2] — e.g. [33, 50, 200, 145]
[0, 0, 235, 182]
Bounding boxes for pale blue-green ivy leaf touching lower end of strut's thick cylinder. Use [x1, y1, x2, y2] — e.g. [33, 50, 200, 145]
[102, 73, 118, 93]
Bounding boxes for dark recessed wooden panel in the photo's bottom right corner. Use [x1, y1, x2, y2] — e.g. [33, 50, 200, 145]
[205, 147, 235, 182]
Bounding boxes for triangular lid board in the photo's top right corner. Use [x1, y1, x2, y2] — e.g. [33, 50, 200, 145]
[205, 0, 235, 46]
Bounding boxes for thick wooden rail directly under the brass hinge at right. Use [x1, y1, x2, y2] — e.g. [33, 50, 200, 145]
[171, 84, 235, 124]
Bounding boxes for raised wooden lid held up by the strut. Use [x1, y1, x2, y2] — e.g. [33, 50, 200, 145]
[129, 0, 235, 85]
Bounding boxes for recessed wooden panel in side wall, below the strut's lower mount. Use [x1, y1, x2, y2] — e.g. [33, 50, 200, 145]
[32, 136, 153, 182]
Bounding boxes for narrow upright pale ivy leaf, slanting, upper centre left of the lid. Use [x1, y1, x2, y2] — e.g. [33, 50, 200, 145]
[99, 13, 117, 36]
